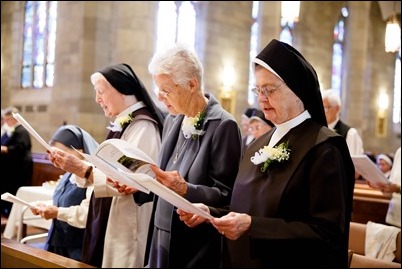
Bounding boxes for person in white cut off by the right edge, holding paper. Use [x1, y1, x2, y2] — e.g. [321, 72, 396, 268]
[370, 147, 401, 228]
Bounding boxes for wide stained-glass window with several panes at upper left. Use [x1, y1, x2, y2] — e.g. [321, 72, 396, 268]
[21, 1, 57, 89]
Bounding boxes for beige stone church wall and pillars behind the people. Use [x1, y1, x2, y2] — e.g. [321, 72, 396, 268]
[1, 1, 400, 153]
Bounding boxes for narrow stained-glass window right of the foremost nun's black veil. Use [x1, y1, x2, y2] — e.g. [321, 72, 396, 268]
[331, 7, 349, 96]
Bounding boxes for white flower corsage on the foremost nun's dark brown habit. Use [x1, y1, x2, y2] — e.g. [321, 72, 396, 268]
[251, 142, 290, 173]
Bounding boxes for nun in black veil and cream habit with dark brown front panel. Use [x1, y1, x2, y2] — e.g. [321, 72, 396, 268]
[51, 63, 164, 268]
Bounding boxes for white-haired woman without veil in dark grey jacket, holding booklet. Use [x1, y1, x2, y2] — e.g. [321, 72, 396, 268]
[122, 44, 241, 268]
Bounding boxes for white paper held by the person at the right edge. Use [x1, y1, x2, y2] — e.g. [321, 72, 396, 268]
[352, 154, 388, 187]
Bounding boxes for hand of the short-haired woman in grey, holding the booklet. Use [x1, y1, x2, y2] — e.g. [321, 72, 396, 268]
[151, 164, 187, 197]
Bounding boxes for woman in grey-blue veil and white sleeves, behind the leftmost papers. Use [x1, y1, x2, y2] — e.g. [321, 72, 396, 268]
[31, 125, 98, 261]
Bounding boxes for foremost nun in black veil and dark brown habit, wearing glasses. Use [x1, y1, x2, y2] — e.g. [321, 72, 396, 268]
[177, 39, 354, 268]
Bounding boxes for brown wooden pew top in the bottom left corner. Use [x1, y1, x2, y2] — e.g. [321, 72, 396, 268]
[1, 237, 95, 268]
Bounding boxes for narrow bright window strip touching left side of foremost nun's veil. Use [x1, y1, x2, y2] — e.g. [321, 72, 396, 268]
[247, 1, 260, 106]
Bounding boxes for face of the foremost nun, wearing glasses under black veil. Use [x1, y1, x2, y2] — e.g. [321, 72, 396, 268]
[255, 67, 304, 124]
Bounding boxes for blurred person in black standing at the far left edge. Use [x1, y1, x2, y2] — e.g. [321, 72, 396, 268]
[1, 107, 33, 217]
